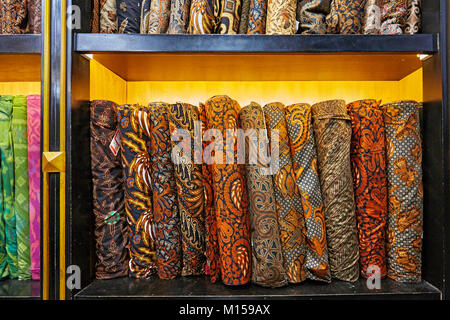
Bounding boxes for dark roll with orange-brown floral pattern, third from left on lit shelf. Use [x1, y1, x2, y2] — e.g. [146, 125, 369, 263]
[149, 102, 182, 279]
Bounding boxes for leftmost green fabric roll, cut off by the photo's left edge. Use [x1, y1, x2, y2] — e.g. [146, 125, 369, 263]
[0, 96, 17, 279]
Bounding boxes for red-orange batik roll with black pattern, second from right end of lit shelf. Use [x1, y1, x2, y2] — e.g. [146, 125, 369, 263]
[347, 99, 388, 278]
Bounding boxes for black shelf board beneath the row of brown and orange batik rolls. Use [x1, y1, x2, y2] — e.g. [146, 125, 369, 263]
[75, 277, 441, 300]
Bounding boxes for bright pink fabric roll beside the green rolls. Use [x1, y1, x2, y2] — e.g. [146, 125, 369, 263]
[27, 95, 41, 280]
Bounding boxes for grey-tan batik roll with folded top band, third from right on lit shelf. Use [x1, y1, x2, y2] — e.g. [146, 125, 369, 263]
[311, 100, 359, 282]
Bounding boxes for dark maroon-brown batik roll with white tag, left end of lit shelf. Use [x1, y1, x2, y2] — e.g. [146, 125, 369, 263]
[90, 100, 129, 279]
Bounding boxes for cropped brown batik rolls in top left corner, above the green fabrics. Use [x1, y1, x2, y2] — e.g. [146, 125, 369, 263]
[0, 0, 42, 34]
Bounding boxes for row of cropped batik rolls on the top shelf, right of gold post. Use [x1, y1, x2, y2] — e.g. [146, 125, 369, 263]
[92, 0, 421, 35]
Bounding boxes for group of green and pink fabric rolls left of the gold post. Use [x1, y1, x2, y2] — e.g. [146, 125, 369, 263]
[0, 95, 41, 280]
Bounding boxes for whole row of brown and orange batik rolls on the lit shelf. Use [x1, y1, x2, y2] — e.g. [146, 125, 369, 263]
[90, 96, 423, 287]
